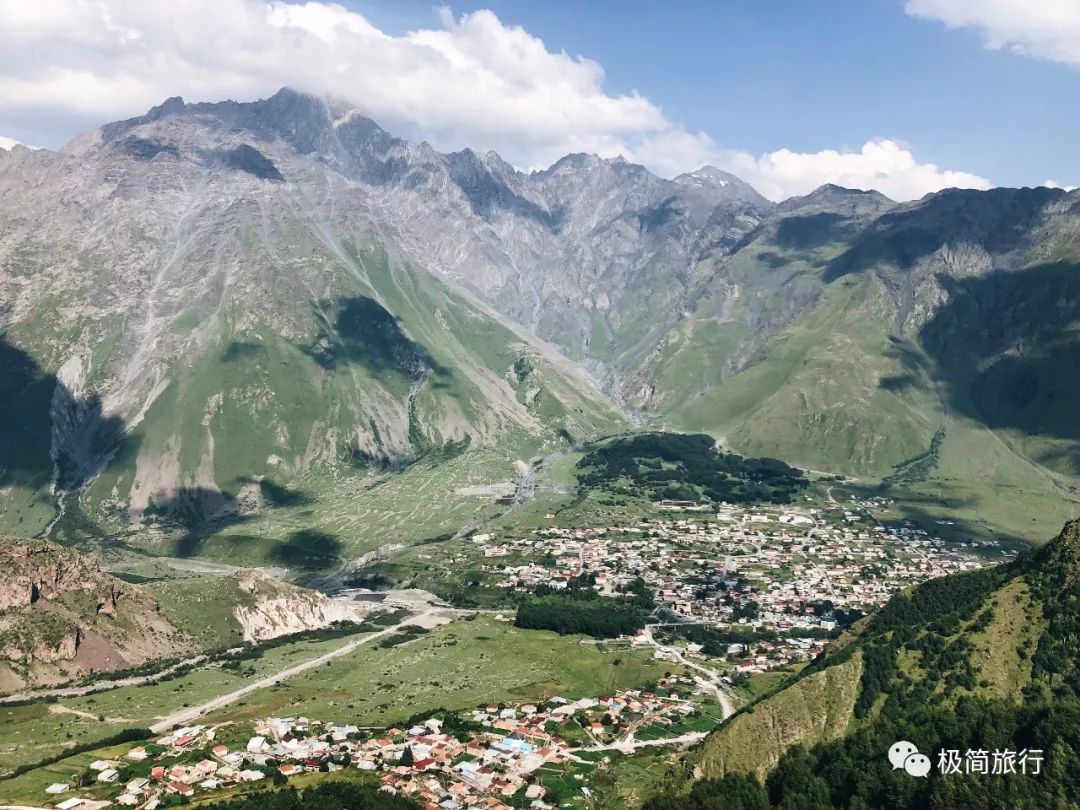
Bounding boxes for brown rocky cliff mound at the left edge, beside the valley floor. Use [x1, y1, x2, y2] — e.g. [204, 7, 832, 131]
[0, 539, 191, 689]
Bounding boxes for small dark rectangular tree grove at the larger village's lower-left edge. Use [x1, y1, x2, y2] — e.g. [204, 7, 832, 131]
[514, 591, 649, 638]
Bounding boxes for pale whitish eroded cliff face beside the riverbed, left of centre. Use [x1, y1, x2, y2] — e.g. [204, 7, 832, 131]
[232, 571, 359, 642]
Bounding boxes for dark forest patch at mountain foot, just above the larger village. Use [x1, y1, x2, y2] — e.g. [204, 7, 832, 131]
[578, 433, 807, 503]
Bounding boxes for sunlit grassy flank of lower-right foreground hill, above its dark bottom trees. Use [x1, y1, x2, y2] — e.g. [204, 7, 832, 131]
[690, 522, 1080, 807]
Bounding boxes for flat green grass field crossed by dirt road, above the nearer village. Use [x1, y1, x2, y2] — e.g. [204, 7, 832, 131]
[0, 616, 681, 801]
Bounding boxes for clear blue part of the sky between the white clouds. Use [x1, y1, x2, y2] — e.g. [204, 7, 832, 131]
[348, 0, 1080, 186]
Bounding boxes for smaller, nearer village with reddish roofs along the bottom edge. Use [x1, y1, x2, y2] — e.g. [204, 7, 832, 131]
[39, 677, 719, 810]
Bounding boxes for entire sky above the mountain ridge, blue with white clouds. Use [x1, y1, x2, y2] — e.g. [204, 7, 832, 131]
[0, 0, 1080, 200]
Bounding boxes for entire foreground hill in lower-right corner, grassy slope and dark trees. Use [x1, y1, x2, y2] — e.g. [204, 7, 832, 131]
[649, 522, 1080, 809]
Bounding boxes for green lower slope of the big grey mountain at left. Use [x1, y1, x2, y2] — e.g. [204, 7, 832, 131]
[29, 224, 624, 568]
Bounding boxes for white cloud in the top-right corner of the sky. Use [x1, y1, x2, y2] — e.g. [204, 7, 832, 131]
[904, 0, 1080, 67]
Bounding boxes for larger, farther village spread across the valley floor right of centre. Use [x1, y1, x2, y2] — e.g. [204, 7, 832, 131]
[472, 498, 1015, 675]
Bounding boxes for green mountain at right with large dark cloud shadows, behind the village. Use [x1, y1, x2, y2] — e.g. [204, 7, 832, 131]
[627, 189, 1080, 541]
